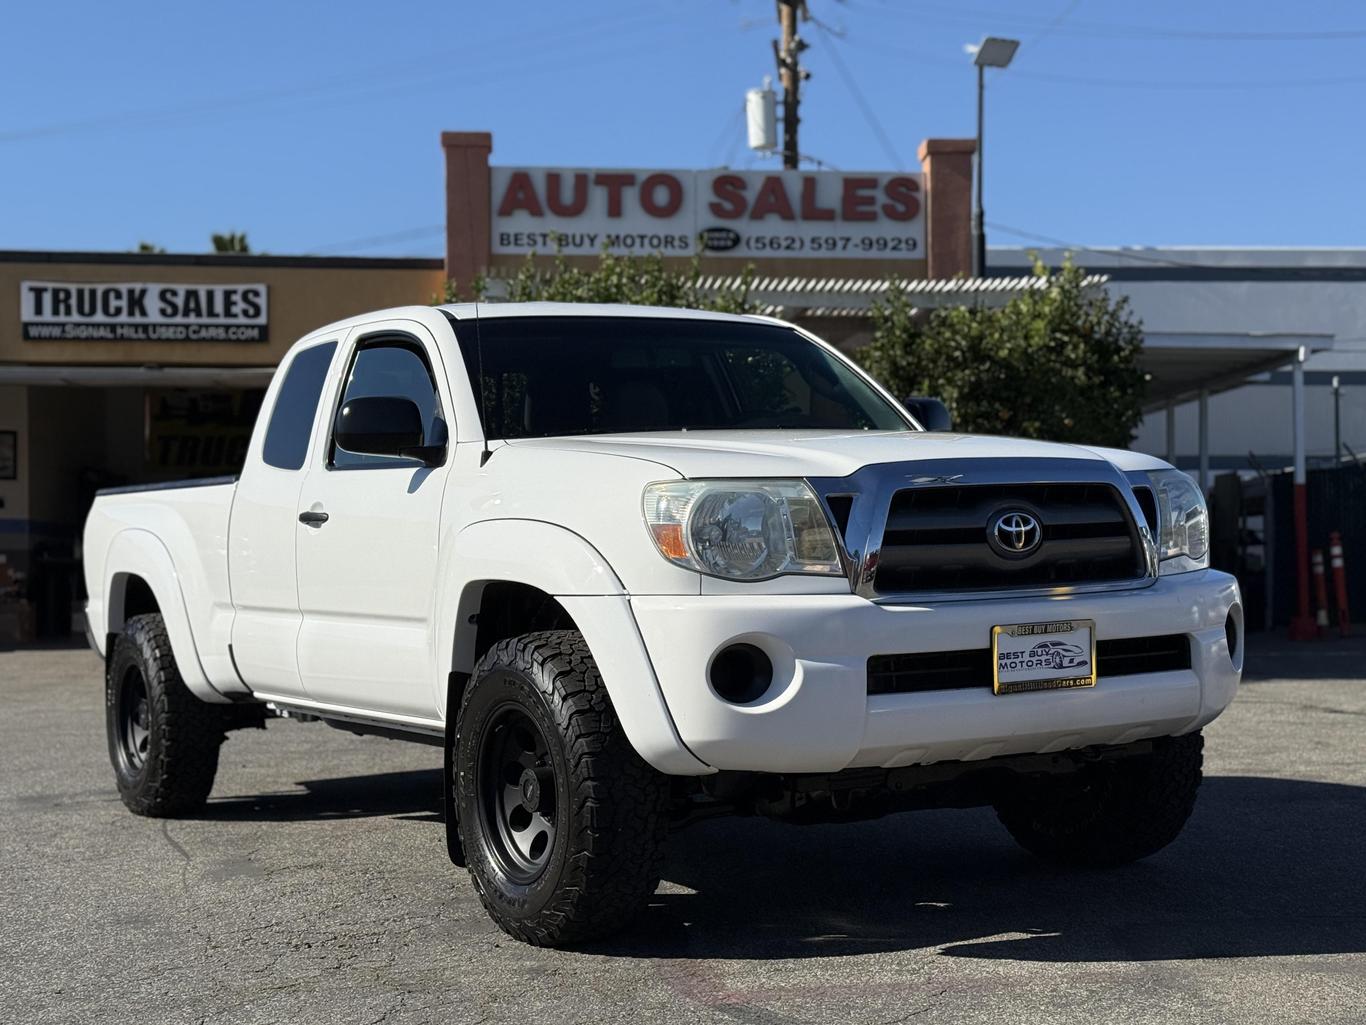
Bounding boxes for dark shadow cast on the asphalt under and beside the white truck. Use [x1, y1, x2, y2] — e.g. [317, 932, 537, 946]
[201, 769, 1366, 962]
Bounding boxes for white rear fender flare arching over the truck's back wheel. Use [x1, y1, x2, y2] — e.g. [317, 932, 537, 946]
[100, 528, 228, 704]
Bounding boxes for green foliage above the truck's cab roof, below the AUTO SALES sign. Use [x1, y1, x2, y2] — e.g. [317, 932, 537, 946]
[441, 250, 758, 313]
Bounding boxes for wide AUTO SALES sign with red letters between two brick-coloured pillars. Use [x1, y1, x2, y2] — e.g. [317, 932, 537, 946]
[489, 167, 925, 260]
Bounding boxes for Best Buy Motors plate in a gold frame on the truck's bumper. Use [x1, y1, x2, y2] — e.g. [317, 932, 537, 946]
[992, 619, 1096, 694]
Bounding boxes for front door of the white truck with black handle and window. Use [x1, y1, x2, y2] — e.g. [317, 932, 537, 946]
[295, 321, 454, 720]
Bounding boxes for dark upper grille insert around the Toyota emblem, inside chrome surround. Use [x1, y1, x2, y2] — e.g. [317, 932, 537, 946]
[873, 484, 1143, 595]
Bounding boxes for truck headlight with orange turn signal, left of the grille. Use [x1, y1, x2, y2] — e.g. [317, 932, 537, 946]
[645, 481, 844, 581]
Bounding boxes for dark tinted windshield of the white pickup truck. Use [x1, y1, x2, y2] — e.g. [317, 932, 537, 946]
[456, 317, 912, 440]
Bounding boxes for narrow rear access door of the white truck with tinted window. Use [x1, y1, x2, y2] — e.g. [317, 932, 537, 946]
[228, 342, 337, 697]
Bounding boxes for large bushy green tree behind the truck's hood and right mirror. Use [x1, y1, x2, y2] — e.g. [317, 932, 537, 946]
[855, 260, 1145, 448]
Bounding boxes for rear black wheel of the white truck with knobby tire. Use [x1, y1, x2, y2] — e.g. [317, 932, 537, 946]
[104, 614, 225, 817]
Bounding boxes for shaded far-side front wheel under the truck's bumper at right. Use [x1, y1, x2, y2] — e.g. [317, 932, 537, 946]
[996, 733, 1205, 868]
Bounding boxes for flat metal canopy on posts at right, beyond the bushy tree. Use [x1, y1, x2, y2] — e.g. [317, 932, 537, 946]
[1139, 332, 1333, 413]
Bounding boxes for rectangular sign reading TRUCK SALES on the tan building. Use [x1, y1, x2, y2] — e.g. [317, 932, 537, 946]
[19, 282, 269, 342]
